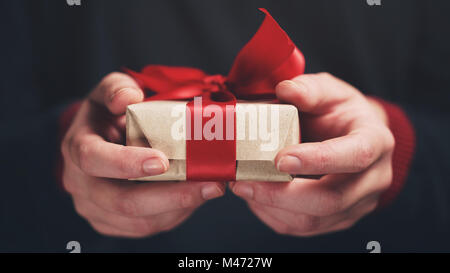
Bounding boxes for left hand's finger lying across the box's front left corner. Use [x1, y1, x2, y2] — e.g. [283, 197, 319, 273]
[69, 131, 169, 179]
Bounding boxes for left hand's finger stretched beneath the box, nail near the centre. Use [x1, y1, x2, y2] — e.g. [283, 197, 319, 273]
[88, 178, 225, 217]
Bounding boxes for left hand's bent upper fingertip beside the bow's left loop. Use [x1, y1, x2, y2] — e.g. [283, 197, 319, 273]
[89, 72, 144, 115]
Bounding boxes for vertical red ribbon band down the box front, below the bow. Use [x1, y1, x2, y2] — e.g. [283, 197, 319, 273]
[186, 93, 236, 181]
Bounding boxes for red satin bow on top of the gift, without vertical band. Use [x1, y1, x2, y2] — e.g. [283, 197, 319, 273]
[126, 8, 305, 100]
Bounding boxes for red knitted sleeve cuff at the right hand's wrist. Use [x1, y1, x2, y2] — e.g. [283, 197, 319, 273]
[375, 98, 416, 208]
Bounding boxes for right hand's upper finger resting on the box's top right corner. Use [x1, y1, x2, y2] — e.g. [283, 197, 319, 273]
[276, 73, 357, 114]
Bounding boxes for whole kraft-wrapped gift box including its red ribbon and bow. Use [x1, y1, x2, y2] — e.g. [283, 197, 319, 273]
[124, 9, 305, 181]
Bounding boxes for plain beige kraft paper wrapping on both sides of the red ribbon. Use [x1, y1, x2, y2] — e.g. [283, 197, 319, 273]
[126, 101, 300, 182]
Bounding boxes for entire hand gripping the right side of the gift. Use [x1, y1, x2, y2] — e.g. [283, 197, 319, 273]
[229, 73, 394, 236]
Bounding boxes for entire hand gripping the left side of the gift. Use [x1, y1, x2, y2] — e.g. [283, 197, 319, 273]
[61, 73, 225, 237]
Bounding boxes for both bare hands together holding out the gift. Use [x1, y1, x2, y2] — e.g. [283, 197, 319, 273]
[61, 73, 394, 237]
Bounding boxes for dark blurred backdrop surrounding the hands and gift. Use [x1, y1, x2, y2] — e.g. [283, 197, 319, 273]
[0, 0, 450, 252]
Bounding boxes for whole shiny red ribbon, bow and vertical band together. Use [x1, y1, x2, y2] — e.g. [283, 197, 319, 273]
[125, 8, 305, 181]
